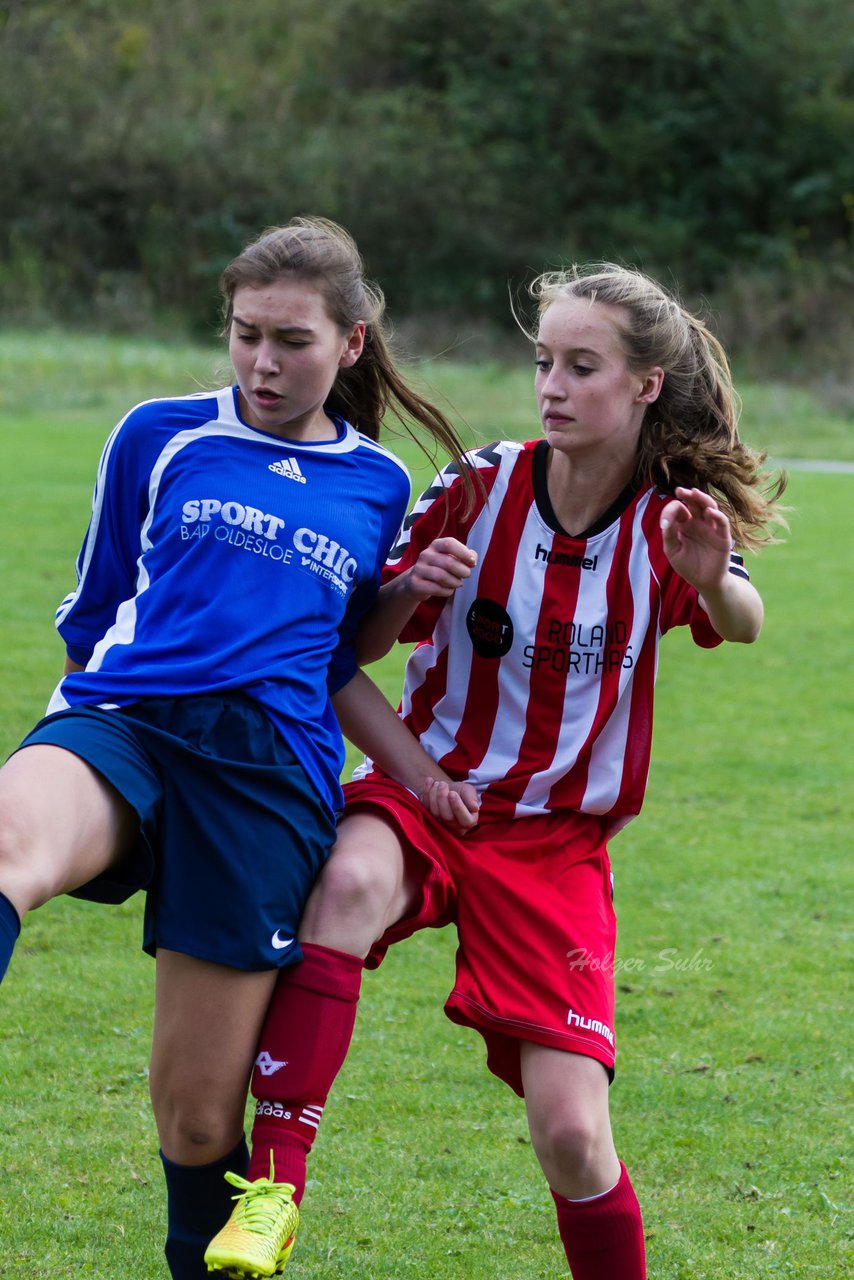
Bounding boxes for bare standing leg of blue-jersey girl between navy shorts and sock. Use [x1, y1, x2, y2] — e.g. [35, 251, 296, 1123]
[150, 948, 277, 1164]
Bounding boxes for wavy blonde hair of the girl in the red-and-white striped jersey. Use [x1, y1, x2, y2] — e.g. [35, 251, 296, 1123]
[528, 262, 786, 550]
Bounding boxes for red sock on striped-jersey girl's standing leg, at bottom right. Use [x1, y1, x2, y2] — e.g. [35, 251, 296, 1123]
[552, 1164, 647, 1280]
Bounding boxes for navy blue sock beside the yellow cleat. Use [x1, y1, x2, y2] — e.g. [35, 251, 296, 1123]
[160, 1138, 250, 1280]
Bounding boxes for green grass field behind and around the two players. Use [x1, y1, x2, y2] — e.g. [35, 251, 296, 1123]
[0, 334, 854, 1280]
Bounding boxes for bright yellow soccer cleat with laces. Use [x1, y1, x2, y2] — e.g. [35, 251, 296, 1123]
[205, 1153, 300, 1280]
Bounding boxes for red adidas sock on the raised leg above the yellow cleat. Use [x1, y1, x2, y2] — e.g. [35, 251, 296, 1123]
[248, 942, 364, 1204]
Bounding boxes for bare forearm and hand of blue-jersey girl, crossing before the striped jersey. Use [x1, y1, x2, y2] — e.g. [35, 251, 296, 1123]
[332, 671, 479, 831]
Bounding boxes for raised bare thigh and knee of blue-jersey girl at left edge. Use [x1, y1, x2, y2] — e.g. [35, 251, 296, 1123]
[0, 744, 138, 914]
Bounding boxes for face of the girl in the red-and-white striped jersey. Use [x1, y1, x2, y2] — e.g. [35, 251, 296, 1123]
[534, 298, 663, 467]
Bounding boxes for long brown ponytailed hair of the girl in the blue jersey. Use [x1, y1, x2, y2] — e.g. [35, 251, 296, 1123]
[219, 218, 470, 485]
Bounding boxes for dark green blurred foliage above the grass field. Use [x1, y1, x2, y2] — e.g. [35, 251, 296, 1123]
[0, 0, 854, 371]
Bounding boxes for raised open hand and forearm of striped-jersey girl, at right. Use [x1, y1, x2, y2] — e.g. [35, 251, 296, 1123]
[661, 488, 764, 644]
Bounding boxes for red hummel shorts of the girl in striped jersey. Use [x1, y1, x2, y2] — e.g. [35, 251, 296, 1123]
[344, 774, 616, 1096]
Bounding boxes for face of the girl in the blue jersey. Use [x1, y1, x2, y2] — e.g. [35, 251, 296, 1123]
[228, 278, 365, 440]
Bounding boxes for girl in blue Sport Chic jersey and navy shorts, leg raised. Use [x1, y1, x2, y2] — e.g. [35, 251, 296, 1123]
[0, 219, 473, 1280]
